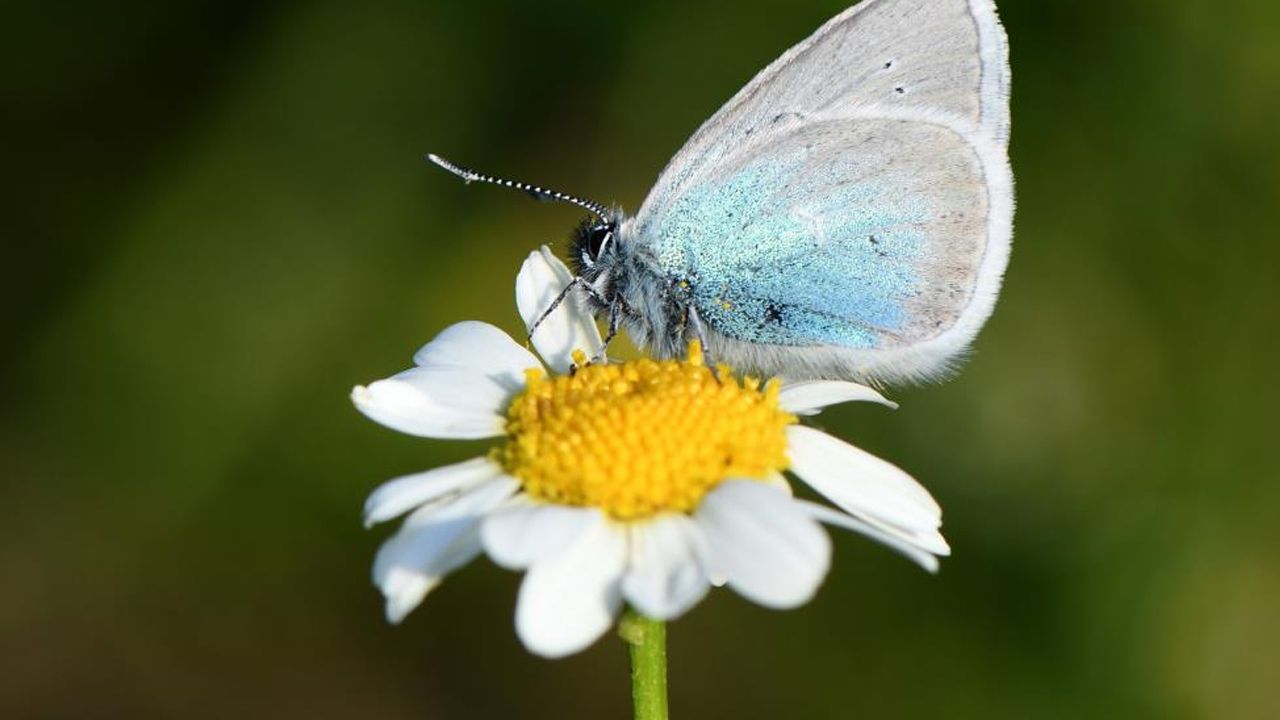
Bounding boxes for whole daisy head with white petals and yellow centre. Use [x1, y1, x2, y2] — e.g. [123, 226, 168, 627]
[352, 247, 948, 657]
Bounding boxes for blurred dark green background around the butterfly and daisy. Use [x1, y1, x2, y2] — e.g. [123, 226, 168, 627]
[0, 0, 1280, 719]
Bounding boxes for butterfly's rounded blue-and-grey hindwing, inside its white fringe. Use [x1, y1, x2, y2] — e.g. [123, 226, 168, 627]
[650, 114, 986, 348]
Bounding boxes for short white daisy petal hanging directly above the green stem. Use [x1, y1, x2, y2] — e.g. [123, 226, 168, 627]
[622, 514, 709, 620]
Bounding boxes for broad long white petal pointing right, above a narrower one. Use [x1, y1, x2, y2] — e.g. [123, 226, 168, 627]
[787, 425, 942, 532]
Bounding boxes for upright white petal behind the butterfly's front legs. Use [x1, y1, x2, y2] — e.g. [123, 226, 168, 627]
[516, 245, 602, 373]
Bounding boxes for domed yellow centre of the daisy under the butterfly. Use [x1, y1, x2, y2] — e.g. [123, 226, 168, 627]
[495, 342, 796, 520]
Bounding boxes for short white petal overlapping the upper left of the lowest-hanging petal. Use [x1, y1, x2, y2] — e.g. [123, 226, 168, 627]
[480, 501, 600, 570]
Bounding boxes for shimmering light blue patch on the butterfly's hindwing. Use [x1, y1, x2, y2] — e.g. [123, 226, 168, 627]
[652, 160, 929, 348]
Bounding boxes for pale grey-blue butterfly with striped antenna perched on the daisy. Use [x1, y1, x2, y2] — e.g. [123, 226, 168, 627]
[429, 0, 1014, 383]
